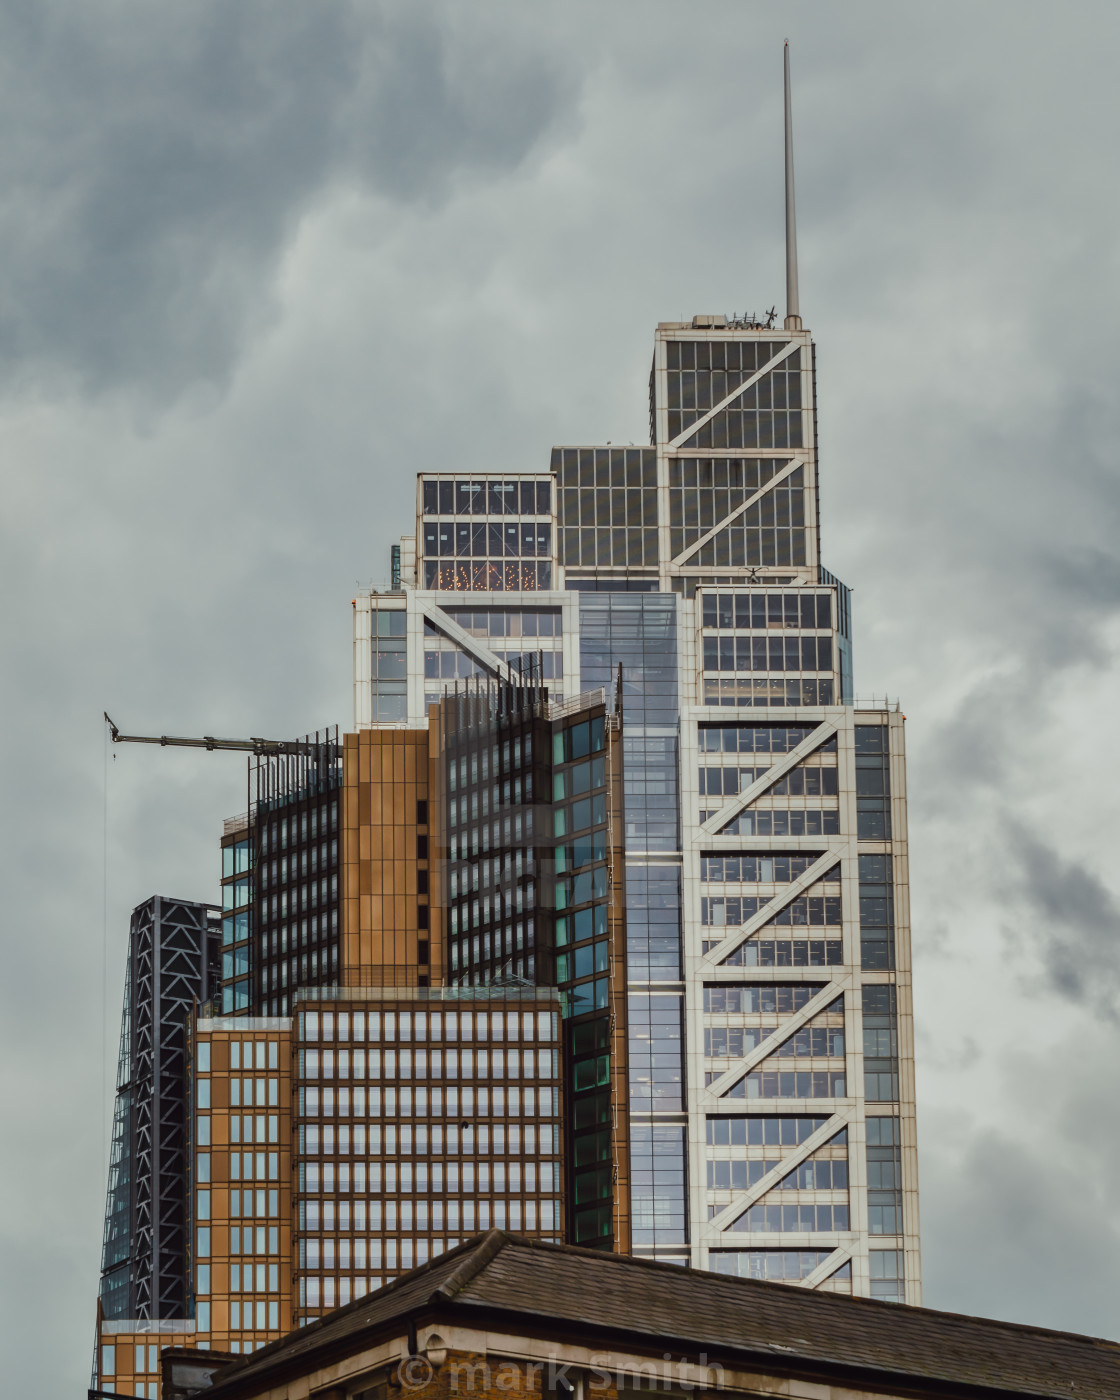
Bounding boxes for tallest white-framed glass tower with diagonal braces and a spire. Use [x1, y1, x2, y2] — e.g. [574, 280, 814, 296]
[364, 60, 921, 1302]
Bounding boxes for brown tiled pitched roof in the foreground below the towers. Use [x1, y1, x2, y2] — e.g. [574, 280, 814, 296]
[207, 1231, 1120, 1400]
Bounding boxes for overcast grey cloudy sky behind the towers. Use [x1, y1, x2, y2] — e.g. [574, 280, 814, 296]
[0, 0, 1120, 1400]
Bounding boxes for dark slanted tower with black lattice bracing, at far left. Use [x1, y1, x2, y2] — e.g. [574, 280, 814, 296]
[98, 895, 218, 1322]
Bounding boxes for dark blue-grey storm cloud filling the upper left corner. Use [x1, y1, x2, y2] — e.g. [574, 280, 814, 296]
[0, 0, 571, 395]
